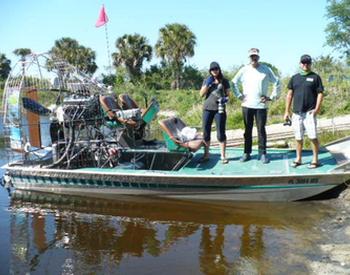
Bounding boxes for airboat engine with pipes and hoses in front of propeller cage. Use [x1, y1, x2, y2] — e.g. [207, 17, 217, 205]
[52, 93, 103, 168]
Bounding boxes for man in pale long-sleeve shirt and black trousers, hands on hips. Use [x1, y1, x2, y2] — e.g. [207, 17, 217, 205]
[232, 48, 281, 163]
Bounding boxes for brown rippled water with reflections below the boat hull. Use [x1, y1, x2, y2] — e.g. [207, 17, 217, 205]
[11, 192, 335, 274]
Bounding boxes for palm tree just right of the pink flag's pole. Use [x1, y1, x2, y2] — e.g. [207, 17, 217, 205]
[112, 33, 152, 80]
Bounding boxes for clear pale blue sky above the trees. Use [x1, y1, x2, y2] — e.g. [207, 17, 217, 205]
[0, 0, 333, 75]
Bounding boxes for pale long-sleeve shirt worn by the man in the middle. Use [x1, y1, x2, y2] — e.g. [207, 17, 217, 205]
[232, 63, 281, 109]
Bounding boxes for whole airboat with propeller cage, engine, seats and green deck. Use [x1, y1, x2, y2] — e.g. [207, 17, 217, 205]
[3, 54, 350, 201]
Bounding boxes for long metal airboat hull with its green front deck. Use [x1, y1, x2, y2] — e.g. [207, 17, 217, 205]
[7, 148, 350, 201]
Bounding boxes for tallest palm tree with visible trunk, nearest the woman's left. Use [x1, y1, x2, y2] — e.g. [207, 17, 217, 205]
[155, 23, 196, 89]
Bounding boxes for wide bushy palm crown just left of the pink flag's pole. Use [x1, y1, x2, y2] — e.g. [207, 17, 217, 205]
[50, 37, 97, 75]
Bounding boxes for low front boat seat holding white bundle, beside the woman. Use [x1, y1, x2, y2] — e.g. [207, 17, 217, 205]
[159, 117, 203, 152]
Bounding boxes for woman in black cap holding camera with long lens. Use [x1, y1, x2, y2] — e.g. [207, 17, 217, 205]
[200, 62, 230, 164]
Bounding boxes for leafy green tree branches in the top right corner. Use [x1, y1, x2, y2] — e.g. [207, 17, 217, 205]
[326, 0, 350, 63]
